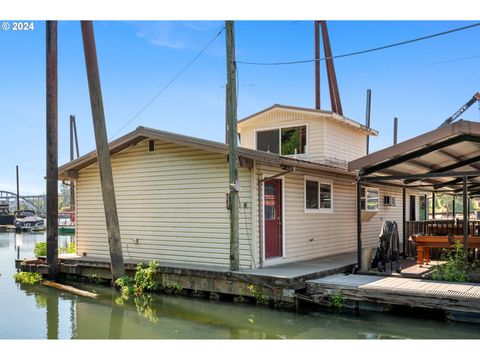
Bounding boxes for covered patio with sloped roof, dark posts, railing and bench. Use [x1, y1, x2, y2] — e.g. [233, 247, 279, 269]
[348, 120, 480, 268]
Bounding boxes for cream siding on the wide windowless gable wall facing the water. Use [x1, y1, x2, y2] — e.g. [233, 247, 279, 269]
[77, 141, 258, 267]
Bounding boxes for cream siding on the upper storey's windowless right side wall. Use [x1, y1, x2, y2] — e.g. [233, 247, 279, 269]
[325, 120, 367, 163]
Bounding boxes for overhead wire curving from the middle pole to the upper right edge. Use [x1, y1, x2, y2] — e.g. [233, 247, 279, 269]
[237, 22, 480, 66]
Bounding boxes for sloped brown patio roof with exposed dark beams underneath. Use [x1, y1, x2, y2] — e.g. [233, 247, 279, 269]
[348, 120, 480, 195]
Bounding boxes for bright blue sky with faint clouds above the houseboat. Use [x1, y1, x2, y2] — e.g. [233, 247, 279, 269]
[0, 21, 480, 194]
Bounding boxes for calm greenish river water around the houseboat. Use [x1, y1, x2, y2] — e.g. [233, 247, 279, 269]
[0, 233, 480, 339]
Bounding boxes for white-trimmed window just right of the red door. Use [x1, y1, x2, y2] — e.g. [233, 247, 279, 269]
[305, 177, 333, 212]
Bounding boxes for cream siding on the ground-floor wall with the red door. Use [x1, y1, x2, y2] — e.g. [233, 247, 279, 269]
[257, 165, 418, 266]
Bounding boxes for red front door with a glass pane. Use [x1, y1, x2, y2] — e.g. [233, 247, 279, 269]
[263, 179, 282, 259]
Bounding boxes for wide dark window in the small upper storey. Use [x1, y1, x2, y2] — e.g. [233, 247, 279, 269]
[256, 125, 307, 155]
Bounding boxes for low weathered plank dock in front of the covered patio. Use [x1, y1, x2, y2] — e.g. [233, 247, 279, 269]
[306, 274, 480, 323]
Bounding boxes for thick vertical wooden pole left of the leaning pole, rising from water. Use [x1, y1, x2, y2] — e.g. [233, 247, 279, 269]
[46, 21, 58, 279]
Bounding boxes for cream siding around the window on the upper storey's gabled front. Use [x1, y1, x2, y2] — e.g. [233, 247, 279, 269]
[238, 109, 325, 161]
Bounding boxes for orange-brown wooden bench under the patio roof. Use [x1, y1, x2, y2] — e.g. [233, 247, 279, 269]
[410, 235, 480, 264]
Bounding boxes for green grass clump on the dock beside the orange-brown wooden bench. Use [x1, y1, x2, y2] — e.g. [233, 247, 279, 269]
[432, 241, 469, 282]
